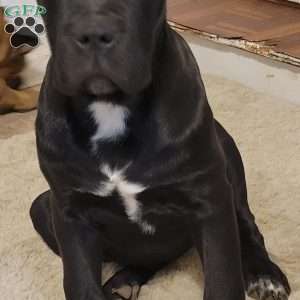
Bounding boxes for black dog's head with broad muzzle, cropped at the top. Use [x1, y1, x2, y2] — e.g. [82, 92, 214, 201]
[38, 0, 166, 96]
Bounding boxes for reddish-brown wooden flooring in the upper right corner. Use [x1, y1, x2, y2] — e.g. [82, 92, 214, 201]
[168, 0, 300, 59]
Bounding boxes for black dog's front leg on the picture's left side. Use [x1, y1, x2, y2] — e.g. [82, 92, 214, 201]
[53, 196, 105, 300]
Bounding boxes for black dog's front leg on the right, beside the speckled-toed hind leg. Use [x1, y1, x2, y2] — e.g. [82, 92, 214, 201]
[193, 179, 245, 300]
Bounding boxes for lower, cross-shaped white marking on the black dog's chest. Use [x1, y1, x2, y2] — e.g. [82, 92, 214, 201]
[93, 164, 155, 234]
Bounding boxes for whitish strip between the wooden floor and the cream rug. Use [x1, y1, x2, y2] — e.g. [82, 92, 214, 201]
[182, 33, 300, 104]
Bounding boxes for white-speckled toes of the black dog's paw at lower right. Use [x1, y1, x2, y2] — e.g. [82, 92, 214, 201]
[247, 277, 290, 300]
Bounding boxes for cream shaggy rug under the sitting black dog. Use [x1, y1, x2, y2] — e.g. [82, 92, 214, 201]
[0, 76, 300, 300]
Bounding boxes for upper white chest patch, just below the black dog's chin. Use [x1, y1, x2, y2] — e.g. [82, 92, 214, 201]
[88, 102, 129, 143]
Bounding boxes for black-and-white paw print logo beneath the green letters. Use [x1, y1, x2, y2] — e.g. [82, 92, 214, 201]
[4, 17, 45, 48]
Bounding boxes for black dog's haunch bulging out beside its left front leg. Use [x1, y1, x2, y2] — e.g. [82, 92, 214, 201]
[30, 191, 59, 255]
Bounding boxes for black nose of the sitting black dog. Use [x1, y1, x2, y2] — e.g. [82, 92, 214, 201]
[76, 31, 115, 48]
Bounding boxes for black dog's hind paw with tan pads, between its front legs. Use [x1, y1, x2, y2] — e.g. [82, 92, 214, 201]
[103, 267, 158, 300]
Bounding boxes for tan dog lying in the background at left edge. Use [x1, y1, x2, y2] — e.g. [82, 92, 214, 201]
[0, 7, 38, 113]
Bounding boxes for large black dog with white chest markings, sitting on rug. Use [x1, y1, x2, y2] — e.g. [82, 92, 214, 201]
[30, 0, 290, 300]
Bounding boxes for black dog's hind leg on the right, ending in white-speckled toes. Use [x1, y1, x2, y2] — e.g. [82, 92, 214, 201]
[217, 121, 291, 300]
